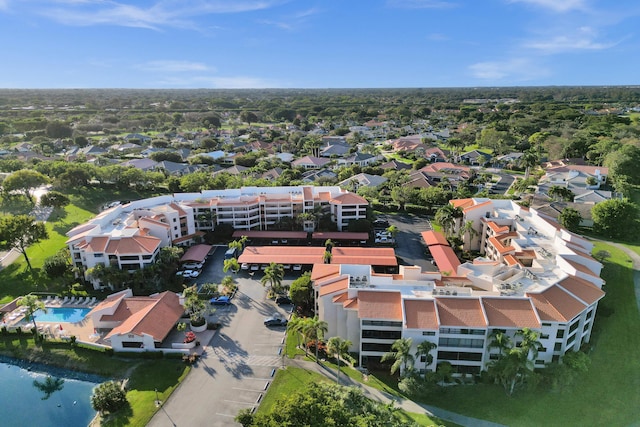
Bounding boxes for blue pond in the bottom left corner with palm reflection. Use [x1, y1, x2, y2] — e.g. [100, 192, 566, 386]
[0, 362, 97, 427]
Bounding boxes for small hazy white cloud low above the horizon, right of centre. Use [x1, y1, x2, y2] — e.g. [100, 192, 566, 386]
[469, 58, 549, 81]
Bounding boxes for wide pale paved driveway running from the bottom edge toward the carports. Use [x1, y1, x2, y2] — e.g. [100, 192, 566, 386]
[148, 256, 290, 427]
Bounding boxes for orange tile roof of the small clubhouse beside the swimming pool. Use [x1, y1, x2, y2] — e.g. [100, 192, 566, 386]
[103, 291, 184, 342]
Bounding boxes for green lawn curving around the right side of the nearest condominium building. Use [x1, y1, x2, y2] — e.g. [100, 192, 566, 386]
[372, 243, 640, 426]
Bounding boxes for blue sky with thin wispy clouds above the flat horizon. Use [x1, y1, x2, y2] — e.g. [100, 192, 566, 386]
[0, 0, 640, 89]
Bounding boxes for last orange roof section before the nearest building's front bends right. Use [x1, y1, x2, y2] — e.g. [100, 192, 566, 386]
[482, 298, 540, 328]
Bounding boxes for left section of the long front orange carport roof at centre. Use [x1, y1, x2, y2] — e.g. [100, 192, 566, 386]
[238, 246, 325, 265]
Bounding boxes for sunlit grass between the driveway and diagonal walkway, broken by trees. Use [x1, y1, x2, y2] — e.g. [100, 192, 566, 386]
[257, 366, 455, 426]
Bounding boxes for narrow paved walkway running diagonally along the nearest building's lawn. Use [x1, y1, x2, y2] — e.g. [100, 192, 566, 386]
[286, 359, 504, 427]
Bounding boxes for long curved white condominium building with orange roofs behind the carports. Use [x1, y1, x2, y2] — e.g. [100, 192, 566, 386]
[67, 186, 368, 286]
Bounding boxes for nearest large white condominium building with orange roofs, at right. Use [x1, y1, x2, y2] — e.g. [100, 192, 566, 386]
[311, 199, 604, 374]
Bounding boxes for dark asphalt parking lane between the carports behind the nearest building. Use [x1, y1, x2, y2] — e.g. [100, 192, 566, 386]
[378, 213, 437, 271]
